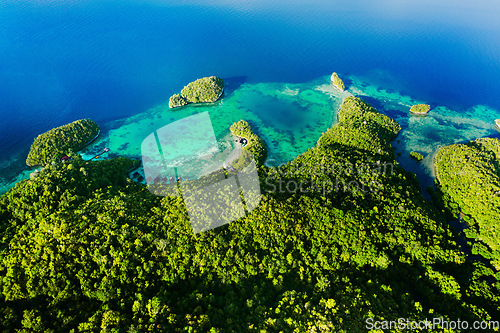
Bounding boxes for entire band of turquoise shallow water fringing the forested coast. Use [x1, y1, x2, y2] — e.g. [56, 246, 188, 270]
[0, 72, 499, 192]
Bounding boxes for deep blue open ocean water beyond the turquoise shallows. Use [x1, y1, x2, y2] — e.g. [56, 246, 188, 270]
[0, 0, 500, 191]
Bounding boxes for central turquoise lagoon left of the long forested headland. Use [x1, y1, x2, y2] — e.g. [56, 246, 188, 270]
[83, 77, 348, 169]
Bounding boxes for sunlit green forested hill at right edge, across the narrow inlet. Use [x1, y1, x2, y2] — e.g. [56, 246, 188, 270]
[435, 138, 500, 272]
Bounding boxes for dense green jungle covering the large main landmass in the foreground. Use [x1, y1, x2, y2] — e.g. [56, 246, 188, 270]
[0, 97, 500, 333]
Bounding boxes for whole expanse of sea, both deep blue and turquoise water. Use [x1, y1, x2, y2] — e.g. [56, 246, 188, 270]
[0, 0, 500, 192]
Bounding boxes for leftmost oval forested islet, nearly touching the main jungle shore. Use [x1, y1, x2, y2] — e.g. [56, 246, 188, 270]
[26, 119, 100, 166]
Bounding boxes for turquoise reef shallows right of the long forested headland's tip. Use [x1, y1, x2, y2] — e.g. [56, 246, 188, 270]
[348, 72, 500, 189]
